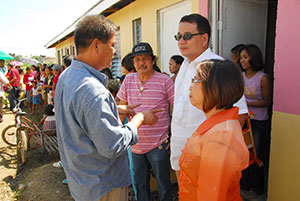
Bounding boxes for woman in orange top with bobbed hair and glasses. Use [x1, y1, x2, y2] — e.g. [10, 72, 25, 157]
[179, 60, 249, 201]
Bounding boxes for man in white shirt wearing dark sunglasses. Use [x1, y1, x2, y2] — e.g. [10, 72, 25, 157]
[170, 14, 248, 178]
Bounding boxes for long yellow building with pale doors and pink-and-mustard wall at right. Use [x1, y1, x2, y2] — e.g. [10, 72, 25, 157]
[46, 0, 300, 201]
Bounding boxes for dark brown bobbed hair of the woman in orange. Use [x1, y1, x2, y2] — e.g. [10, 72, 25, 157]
[197, 60, 244, 113]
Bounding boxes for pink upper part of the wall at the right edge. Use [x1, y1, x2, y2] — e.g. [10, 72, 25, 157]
[273, 0, 300, 115]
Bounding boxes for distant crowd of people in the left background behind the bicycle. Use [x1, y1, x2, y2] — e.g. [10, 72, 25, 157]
[0, 56, 72, 125]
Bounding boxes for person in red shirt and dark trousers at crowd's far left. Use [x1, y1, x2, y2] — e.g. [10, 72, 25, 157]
[7, 63, 21, 111]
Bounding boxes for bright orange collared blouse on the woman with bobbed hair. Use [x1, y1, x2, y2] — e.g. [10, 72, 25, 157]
[179, 107, 249, 201]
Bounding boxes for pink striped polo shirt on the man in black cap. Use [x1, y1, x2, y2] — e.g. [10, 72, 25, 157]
[117, 71, 174, 154]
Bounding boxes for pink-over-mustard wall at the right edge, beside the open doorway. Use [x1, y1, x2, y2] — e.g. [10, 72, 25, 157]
[268, 0, 300, 201]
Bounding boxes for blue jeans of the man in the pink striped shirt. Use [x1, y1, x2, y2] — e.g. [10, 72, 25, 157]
[132, 143, 172, 201]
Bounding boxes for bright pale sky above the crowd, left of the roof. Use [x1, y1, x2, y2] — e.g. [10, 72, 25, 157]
[0, 0, 99, 56]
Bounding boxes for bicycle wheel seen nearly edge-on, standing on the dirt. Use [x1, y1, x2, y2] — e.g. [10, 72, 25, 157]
[17, 127, 28, 164]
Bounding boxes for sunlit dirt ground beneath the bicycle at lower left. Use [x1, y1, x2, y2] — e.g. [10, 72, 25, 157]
[0, 110, 73, 201]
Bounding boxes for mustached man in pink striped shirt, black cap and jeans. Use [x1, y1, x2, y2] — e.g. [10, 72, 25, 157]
[117, 43, 174, 201]
